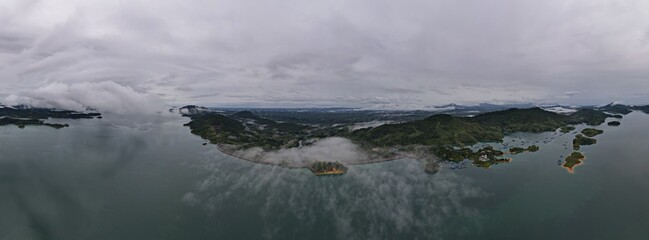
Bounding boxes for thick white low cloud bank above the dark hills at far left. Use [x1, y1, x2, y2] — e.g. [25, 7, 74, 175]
[3, 81, 164, 114]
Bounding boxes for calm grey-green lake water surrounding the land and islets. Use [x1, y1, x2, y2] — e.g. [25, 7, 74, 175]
[0, 112, 649, 240]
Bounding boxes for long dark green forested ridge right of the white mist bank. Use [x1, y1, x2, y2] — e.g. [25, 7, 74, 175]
[350, 108, 611, 146]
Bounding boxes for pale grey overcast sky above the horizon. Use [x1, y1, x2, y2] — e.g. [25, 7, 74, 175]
[0, 0, 649, 110]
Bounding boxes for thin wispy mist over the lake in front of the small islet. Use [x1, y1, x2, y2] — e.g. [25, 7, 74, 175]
[183, 159, 484, 239]
